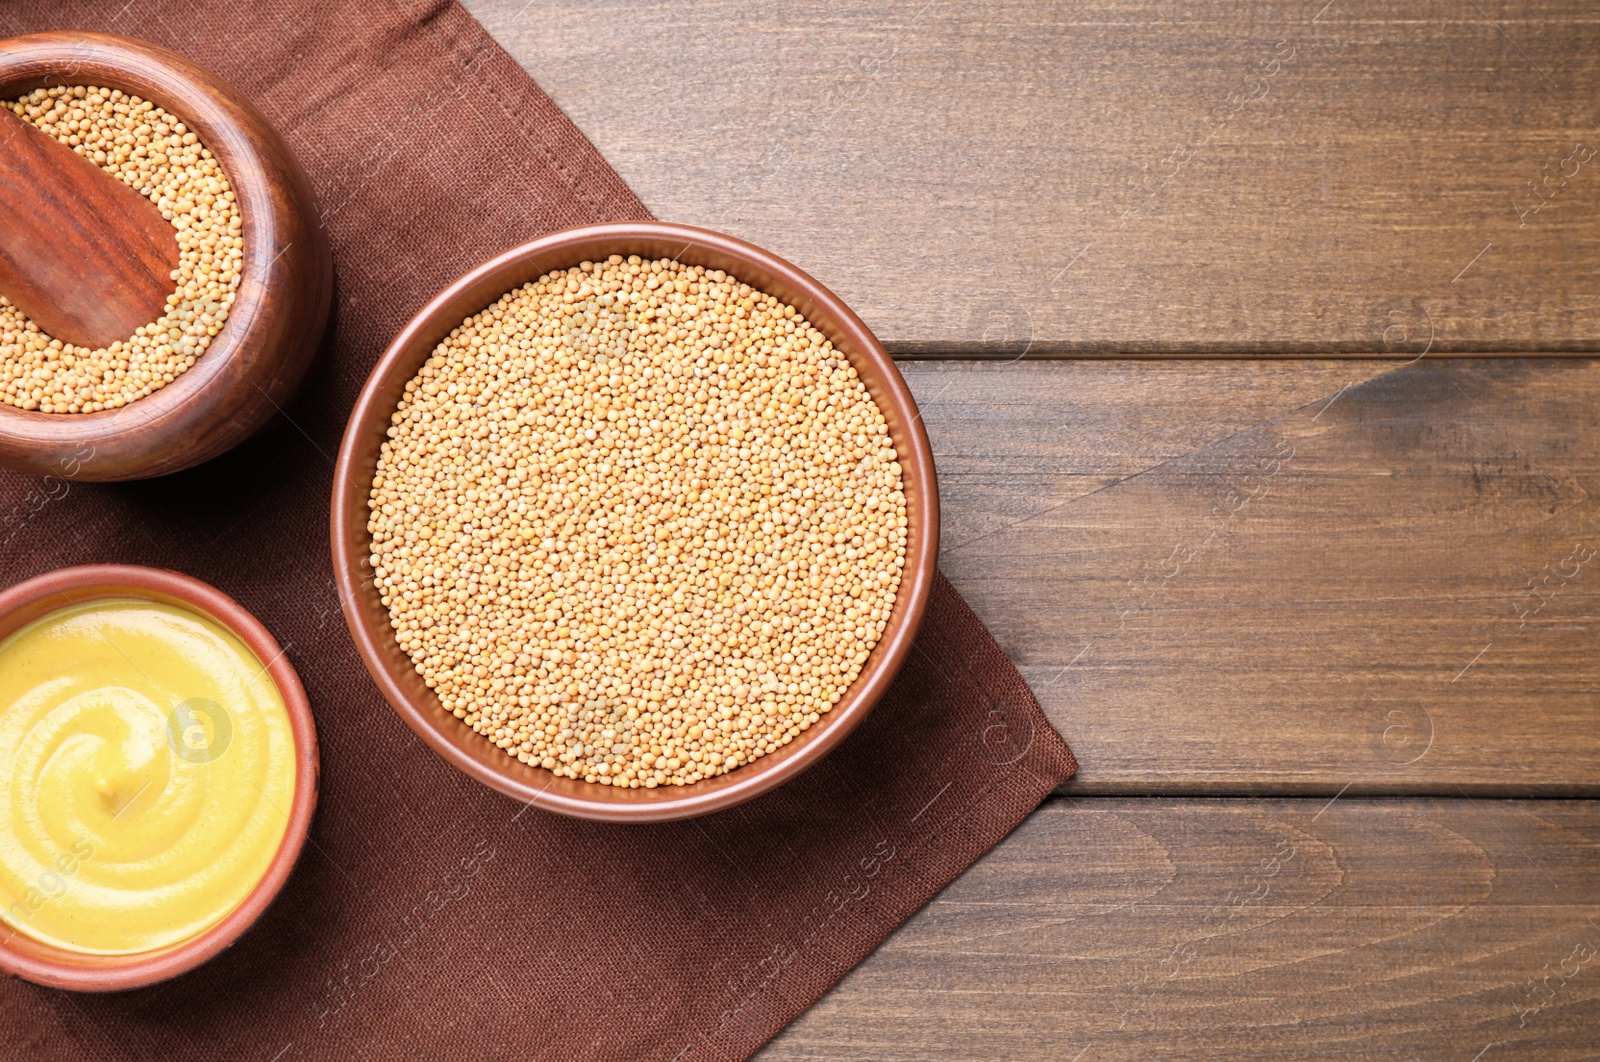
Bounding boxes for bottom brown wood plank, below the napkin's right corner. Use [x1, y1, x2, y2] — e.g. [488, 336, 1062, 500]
[758, 797, 1600, 1062]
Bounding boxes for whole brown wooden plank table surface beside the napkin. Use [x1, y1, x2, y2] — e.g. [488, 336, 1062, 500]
[469, 0, 1600, 1062]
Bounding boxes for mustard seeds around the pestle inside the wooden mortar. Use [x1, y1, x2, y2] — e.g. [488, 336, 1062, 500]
[0, 85, 245, 413]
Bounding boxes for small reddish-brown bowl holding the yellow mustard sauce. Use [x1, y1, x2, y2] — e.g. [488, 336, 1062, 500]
[0, 565, 317, 992]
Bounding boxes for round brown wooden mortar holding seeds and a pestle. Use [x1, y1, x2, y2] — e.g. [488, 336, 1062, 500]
[0, 30, 333, 480]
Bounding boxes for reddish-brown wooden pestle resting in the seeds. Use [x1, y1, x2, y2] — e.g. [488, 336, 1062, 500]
[0, 107, 178, 349]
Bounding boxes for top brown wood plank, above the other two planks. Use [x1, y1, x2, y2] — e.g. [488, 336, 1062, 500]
[467, 0, 1600, 357]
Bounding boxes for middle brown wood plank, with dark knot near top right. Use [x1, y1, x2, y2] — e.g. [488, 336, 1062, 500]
[904, 358, 1600, 795]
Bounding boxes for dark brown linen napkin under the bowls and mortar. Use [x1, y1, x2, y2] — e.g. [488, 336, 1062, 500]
[0, 0, 1075, 1062]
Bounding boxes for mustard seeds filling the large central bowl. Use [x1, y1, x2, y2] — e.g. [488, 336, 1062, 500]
[368, 256, 906, 789]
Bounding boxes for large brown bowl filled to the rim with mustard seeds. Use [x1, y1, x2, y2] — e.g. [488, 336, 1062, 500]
[333, 222, 939, 822]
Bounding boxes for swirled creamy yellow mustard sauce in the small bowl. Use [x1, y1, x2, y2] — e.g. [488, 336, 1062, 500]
[0, 598, 296, 955]
